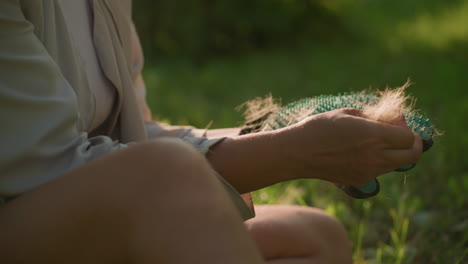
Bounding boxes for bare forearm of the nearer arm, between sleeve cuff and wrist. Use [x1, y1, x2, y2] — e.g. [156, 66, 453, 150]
[207, 131, 291, 193]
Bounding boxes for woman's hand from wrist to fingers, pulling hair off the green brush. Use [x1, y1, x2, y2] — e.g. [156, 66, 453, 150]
[278, 109, 422, 186]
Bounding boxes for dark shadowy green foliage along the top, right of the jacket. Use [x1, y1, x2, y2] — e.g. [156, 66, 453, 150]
[134, 0, 344, 59]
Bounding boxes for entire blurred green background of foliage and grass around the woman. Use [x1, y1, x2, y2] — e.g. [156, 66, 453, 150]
[135, 0, 468, 264]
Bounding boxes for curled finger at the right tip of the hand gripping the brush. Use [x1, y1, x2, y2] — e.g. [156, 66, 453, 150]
[383, 132, 423, 168]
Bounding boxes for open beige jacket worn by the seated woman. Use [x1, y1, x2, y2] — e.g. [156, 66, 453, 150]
[0, 0, 251, 218]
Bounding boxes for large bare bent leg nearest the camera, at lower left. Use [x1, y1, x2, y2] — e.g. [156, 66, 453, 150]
[0, 139, 263, 264]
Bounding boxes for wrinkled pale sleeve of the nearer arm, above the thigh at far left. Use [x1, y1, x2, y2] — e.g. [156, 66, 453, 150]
[0, 0, 126, 198]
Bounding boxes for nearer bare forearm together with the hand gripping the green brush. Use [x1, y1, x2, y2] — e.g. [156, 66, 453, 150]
[207, 109, 422, 193]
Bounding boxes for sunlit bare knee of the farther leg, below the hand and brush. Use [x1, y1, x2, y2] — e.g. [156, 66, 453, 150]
[245, 206, 352, 264]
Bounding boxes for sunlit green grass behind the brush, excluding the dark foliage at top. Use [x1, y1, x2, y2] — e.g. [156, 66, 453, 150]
[145, 1, 468, 264]
